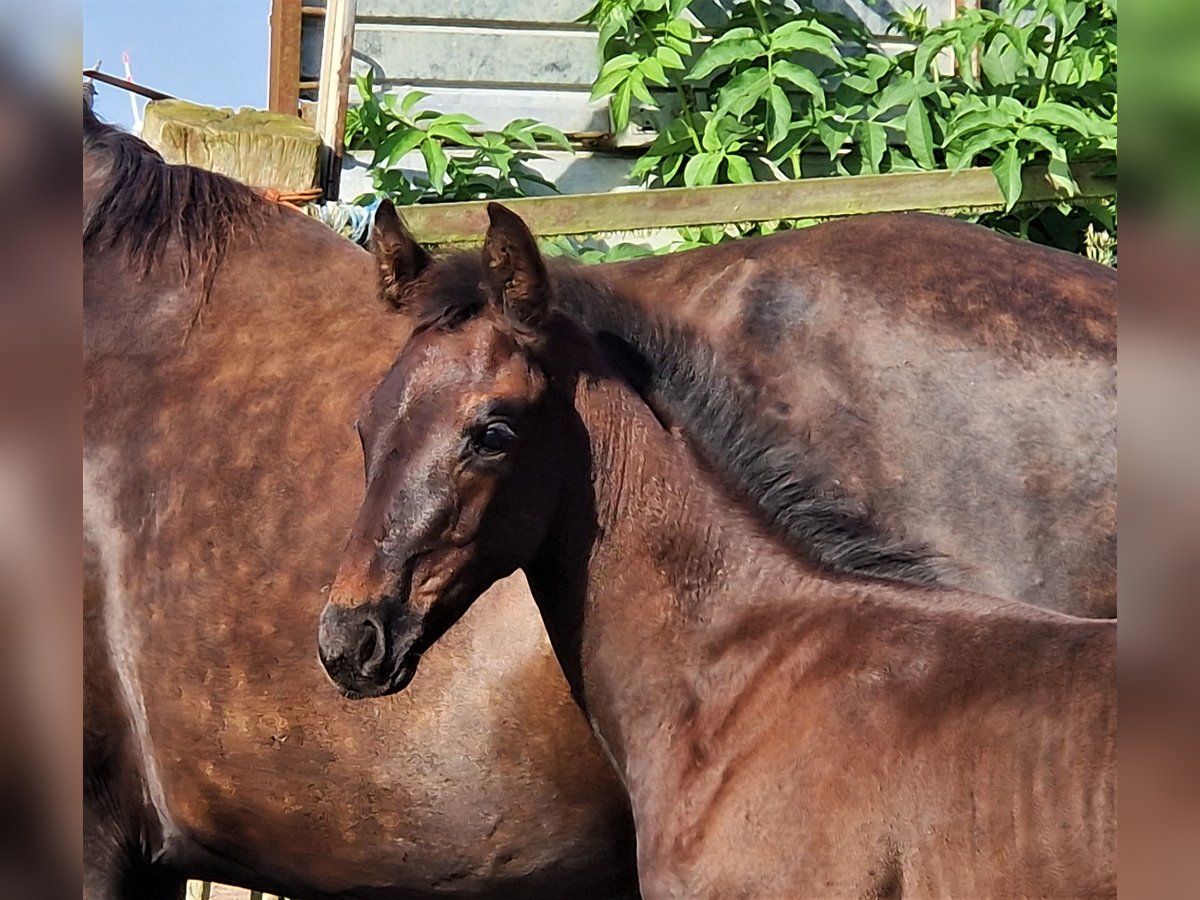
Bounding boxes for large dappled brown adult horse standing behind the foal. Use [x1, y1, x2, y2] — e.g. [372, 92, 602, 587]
[83, 97, 1116, 900]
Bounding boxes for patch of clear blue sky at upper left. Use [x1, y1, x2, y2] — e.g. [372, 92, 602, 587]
[83, 0, 271, 127]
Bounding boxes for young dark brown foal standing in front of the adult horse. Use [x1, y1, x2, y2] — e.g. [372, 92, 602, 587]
[318, 204, 1116, 900]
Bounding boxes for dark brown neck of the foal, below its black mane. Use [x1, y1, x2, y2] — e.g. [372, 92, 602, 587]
[527, 362, 817, 773]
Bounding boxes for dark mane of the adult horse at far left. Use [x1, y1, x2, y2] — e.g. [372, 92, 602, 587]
[83, 101, 277, 301]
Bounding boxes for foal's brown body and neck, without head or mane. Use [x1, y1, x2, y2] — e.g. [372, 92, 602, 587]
[561, 451, 1116, 900]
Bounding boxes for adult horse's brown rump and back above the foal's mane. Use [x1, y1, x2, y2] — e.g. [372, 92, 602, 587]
[604, 215, 1116, 617]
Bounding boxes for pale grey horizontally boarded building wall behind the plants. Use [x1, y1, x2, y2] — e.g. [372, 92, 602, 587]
[288, 0, 955, 198]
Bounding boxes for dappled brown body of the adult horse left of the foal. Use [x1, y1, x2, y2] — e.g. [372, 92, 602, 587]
[84, 116, 634, 899]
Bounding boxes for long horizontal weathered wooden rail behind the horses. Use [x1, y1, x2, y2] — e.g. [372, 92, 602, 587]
[393, 167, 1116, 244]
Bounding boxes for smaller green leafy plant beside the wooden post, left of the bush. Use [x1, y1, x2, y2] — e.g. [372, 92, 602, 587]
[346, 73, 571, 204]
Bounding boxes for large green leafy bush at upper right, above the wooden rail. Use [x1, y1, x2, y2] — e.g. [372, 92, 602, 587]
[587, 0, 1117, 248]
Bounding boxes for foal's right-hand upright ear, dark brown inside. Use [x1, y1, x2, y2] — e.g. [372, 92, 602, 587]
[484, 203, 551, 329]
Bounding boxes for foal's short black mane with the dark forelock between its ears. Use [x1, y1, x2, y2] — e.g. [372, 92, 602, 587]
[410, 253, 942, 586]
